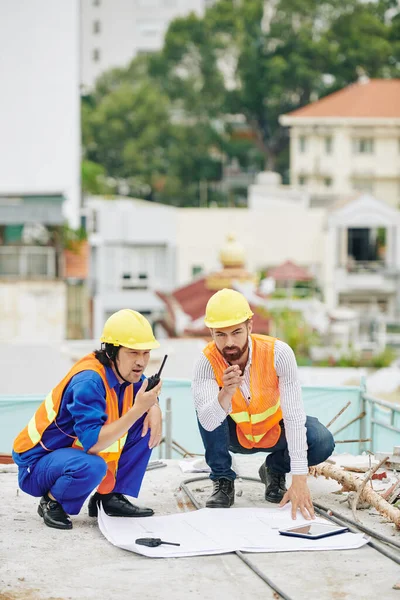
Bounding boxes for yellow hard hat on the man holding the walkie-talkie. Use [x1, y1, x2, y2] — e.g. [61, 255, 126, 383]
[100, 308, 160, 350]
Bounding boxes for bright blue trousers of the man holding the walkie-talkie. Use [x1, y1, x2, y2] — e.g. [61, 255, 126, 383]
[18, 416, 151, 515]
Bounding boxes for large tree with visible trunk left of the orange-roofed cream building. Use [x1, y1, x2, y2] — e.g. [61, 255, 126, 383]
[152, 0, 397, 169]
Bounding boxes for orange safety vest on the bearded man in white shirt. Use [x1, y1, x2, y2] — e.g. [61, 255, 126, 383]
[203, 334, 282, 449]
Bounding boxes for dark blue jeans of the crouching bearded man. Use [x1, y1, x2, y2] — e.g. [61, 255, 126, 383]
[198, 416, 335, 480]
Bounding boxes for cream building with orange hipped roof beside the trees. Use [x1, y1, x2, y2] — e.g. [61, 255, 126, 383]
[280, 79, 400, 208]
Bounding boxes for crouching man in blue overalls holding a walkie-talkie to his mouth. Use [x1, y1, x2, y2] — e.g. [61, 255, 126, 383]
[13, 309, 162, 529]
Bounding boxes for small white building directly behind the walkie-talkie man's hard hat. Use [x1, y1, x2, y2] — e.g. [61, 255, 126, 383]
[86, 198, 177, 338]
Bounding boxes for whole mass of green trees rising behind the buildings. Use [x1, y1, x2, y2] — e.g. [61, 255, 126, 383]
[82, 0, 400, 206]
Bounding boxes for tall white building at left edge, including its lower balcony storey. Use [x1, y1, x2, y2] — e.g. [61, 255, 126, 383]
[0, 0, 80, 344]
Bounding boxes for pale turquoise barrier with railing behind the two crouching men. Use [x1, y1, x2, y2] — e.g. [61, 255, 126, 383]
[0, 379, 400, 457]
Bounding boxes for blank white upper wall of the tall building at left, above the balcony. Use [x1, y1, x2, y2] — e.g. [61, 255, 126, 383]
[0, 0, 80, 226]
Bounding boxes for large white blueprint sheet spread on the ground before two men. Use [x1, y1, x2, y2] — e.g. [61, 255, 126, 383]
[98, 506, 368, 558]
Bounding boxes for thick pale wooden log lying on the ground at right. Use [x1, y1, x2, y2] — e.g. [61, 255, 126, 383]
[310, 463, 400, 529]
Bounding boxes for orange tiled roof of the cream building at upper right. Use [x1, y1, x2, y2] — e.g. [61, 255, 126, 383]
[286, 79, 400, 119]
